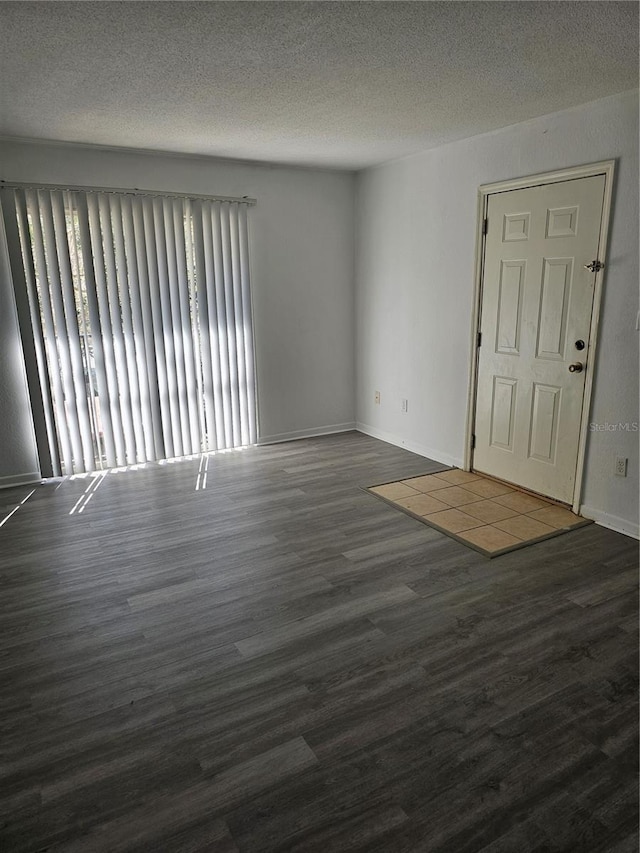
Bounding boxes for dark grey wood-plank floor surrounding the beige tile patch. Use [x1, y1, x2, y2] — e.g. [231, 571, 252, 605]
[0, 433, 638, 853]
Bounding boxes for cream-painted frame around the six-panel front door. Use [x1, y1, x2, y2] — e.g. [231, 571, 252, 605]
[464, 160, 615, 512]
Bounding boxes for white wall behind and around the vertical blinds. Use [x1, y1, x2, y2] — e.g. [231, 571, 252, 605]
[0, 140, 355, 486]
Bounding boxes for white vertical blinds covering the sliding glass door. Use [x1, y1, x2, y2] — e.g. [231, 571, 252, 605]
[2, 188, 256, 474]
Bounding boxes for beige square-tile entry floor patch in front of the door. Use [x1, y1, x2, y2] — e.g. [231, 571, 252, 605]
[367, 468, 590, 557]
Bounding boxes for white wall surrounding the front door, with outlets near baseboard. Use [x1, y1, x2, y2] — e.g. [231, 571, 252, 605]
[356, 92, 639, 535]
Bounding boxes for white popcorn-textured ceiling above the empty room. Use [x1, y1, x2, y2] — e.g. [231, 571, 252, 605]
[0, 0, 638, 168]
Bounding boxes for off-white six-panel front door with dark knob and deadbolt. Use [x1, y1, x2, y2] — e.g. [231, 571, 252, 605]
[473, 175, 605, 503]
